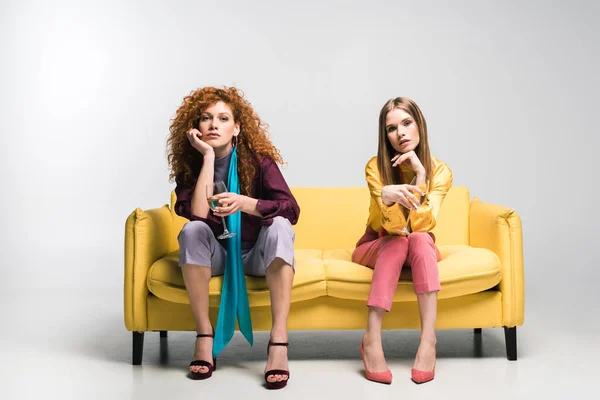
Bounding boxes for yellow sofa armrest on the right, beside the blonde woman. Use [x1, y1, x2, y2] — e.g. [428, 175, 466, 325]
[469, 198, 525, 327]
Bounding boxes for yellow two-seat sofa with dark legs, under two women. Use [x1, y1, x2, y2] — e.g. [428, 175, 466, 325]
[124, 186, 524, 365]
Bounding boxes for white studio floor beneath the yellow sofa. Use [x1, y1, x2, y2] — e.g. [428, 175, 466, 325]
[0, 290, 600, 400]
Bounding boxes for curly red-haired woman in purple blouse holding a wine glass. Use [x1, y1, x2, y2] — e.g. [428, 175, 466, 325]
[168, 87, 300, 389]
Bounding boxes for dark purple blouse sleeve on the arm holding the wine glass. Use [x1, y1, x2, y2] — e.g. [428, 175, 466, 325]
[256, 157, 300, 225]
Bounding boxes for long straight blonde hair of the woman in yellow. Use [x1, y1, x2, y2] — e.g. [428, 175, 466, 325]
[377, 97, 433, 185]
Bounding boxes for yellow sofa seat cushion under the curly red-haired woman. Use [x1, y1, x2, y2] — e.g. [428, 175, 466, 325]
[146, 250, 327, 307]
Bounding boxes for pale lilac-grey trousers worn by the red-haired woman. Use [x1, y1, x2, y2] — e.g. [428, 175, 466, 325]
[177, 217, 296, 276]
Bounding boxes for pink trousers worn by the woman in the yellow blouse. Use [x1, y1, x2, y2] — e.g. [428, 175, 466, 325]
[352, 232, 441, 311]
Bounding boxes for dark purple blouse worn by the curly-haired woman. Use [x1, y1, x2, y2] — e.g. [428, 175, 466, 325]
[175, 157, 300, 248]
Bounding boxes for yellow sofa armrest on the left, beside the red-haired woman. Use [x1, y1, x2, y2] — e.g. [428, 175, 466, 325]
[123, 205, 174, 332]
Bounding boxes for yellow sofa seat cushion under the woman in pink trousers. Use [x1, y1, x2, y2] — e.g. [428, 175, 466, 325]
[323, 245, 500, 302]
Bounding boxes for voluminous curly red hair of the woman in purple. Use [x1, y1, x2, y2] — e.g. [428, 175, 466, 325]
[167, 87, 283, 196]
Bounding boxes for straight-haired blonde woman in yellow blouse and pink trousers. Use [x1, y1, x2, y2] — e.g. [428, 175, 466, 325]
[352, 97, 452, 384]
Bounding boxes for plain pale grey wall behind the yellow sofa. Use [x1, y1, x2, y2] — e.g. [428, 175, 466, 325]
[0, 0, 600, 316]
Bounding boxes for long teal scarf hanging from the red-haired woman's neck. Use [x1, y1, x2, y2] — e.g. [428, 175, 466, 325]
[213, 147, 253, 356]
